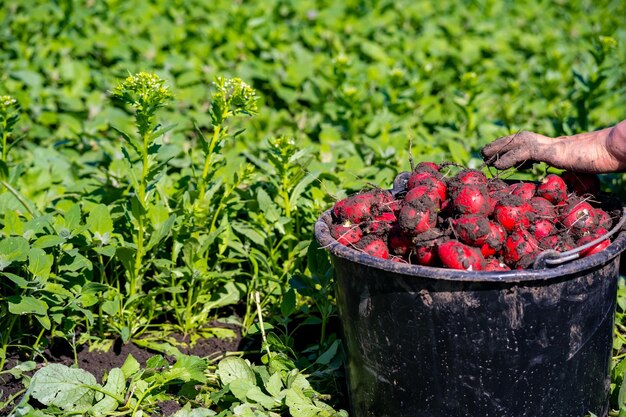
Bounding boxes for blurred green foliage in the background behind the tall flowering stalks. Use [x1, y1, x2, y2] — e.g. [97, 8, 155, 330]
[0, 0, 626, 184]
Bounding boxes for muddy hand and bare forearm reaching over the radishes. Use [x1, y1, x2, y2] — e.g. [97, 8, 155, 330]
[482, 120, 626, 173]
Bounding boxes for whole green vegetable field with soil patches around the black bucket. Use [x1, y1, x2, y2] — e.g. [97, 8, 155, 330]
[0, 0, 626, 417]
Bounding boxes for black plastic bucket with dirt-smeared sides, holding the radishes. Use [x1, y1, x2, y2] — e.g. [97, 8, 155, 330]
[315, 190, 626, 417]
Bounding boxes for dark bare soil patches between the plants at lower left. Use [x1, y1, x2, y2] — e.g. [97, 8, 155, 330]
[0, 322, 242, 417]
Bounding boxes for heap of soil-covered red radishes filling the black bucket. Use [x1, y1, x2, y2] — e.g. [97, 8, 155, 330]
[330, 162, 620, 271]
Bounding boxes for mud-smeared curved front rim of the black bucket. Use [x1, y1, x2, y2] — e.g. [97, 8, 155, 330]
[315, 209, 626, 282]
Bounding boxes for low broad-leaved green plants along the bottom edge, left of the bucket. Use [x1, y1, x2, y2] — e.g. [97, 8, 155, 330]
[10, 354, 348, 417]
